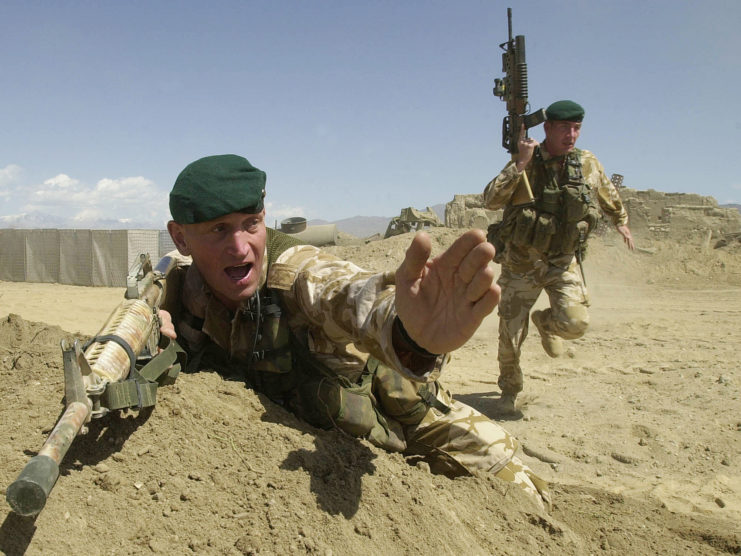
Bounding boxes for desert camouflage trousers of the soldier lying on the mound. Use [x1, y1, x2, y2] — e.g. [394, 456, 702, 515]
[373, 365, 551, 510]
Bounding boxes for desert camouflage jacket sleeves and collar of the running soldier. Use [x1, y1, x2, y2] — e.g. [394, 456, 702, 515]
[484, 148, 628, 226]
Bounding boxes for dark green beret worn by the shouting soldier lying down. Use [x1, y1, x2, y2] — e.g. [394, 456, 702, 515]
[170, 154, 265, 224]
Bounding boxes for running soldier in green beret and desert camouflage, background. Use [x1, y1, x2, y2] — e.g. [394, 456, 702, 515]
[484, 100, 634, 413]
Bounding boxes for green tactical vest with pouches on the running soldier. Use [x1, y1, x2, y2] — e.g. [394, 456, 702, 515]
[489, 146, 600, 261]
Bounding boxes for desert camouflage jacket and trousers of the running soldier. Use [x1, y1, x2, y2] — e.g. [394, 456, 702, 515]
[484, 144, 628, 394]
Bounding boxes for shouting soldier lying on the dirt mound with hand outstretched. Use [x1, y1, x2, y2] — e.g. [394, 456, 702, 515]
[160, 155, 550, 507]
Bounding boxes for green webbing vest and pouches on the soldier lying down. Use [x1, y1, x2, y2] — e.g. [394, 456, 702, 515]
[177, 228, 440, 451]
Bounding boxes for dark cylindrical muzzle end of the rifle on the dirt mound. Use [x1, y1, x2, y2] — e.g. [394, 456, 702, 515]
[5, 455, 59, 516]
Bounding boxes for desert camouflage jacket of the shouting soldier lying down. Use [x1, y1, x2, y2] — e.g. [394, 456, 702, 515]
[170, 239, 446, 382]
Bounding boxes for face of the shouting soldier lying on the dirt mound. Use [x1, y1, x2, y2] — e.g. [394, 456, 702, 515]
[167, 210, 266, 310]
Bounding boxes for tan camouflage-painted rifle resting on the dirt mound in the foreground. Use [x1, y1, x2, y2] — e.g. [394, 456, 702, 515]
[6, 255, 185, 516]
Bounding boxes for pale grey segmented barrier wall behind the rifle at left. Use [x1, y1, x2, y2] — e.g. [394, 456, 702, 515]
[0, 229, 175, 286]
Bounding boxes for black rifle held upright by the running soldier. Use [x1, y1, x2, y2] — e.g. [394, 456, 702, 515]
[494, 8, 545, 206]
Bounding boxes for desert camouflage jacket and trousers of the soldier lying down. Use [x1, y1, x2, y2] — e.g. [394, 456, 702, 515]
[169, 237, 550, 507]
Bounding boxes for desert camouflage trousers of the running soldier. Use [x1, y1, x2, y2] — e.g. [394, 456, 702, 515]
[497, 260, 589, 394]
